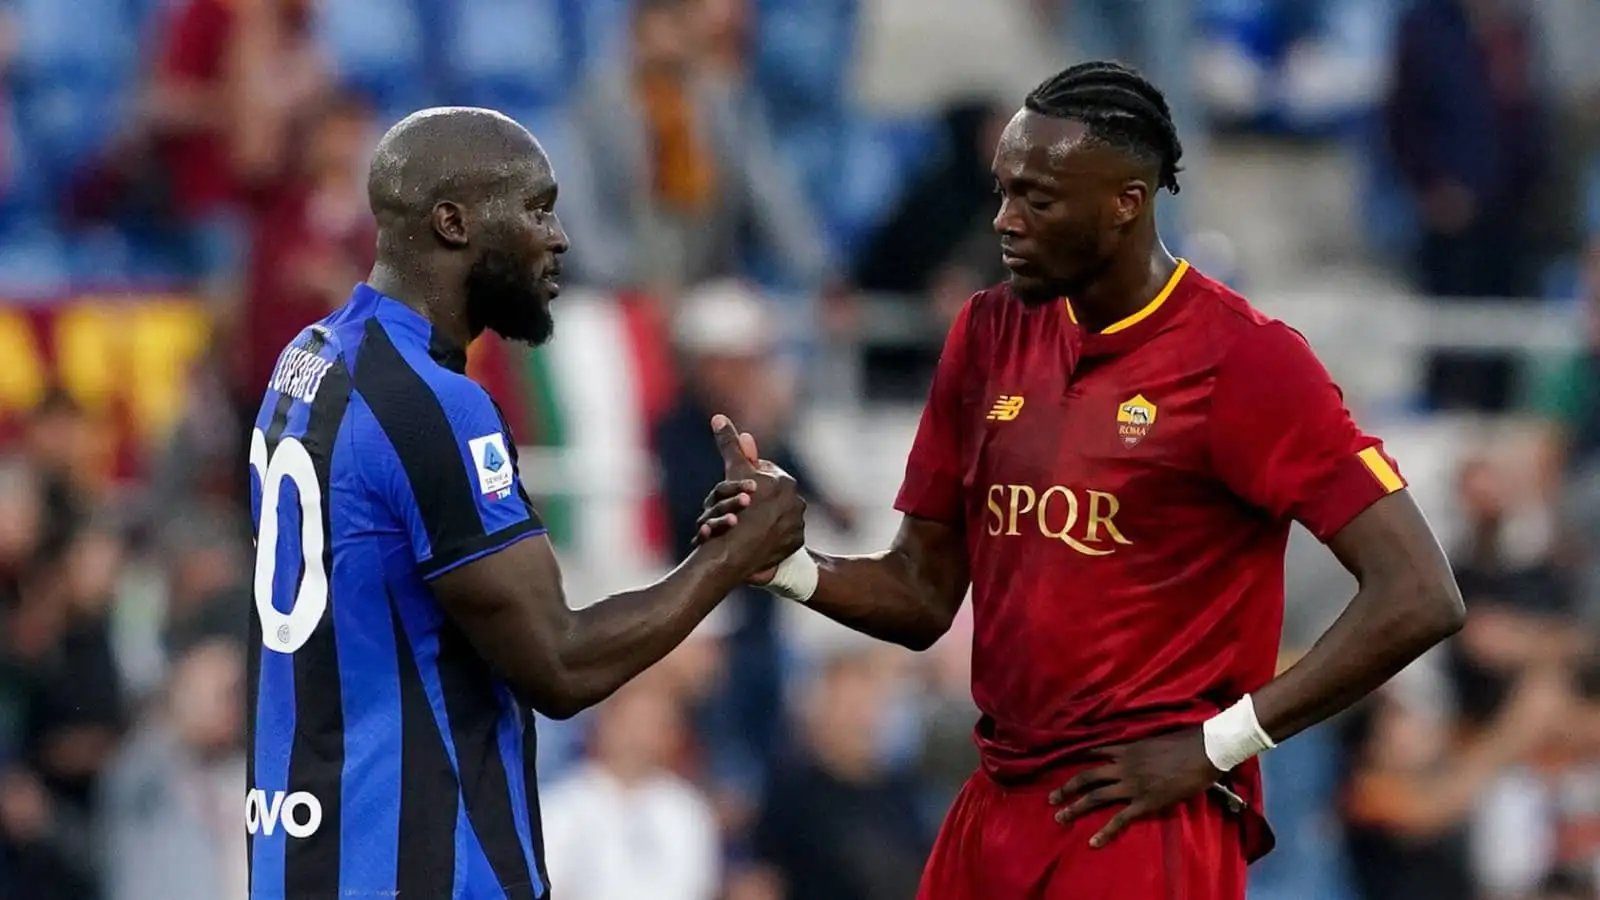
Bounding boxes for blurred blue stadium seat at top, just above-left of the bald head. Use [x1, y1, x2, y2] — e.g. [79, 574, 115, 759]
[320, 0, 434, 119]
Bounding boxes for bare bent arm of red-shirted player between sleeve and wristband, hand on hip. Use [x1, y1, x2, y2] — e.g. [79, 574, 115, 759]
[1253, 490, 1466, 741]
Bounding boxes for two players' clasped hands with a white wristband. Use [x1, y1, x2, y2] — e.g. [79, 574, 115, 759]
[694, 415, 816, 589]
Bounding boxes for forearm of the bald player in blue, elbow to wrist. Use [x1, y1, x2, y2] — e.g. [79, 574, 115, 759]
[550, 551, 739, 717]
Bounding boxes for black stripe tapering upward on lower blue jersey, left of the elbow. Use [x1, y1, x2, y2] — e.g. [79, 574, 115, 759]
[389, 594, 461, 898]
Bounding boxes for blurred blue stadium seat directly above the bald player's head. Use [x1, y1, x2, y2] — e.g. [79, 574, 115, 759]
[443, 0, 582, 109]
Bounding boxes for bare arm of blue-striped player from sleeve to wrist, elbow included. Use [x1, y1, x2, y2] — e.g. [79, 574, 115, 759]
[432, 536, 742, 719]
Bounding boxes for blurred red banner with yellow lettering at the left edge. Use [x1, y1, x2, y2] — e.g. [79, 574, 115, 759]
[0, 295, 210, 476]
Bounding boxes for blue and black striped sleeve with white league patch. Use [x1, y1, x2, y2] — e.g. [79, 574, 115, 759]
[370, 371, 544, 578]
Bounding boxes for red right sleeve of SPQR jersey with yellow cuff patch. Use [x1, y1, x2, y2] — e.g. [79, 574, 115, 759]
[1210, 322, 1406, 541]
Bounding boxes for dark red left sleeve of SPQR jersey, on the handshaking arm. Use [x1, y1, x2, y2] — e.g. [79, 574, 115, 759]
[894, 299, 973, 522]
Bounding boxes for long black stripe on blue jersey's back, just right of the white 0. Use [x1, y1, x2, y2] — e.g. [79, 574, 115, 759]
[283, 352, 350, 900]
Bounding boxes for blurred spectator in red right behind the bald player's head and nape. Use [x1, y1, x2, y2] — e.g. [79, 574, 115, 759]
[237, 89, 378, 405]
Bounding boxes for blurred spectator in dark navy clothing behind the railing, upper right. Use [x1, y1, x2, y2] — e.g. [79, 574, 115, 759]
[1387, 0, 1549, 410]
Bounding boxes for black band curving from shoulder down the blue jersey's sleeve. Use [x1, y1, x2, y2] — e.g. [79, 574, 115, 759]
[355, 319, 483, 577]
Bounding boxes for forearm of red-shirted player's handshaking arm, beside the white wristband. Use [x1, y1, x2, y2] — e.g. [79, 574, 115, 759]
[806, 549, 965, 650]
